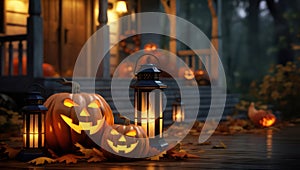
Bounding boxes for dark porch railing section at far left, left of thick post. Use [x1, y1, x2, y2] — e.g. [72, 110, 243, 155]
[0, 34, 27, 76]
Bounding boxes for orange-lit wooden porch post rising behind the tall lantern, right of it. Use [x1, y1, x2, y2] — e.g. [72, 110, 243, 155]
[161, 0, 177, 66]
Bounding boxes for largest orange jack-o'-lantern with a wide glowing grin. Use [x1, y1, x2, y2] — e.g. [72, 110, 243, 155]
[44, 79, 114, 154]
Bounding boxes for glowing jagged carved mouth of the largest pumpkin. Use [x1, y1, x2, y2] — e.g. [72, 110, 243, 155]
[60, 114, 105, 135]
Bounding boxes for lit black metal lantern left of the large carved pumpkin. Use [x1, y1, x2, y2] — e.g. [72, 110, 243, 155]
[19, 92, 47, 161]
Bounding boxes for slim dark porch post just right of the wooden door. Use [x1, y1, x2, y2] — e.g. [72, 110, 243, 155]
[98, 0, 110, 78]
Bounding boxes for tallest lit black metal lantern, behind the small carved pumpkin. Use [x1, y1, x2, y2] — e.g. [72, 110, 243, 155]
[131, 64, 167, 139]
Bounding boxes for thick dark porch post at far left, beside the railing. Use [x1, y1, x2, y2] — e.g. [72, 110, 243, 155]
[27, 0, 43, 78]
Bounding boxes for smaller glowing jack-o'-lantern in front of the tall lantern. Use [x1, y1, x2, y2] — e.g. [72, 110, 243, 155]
[101, 124, 150, 160]
